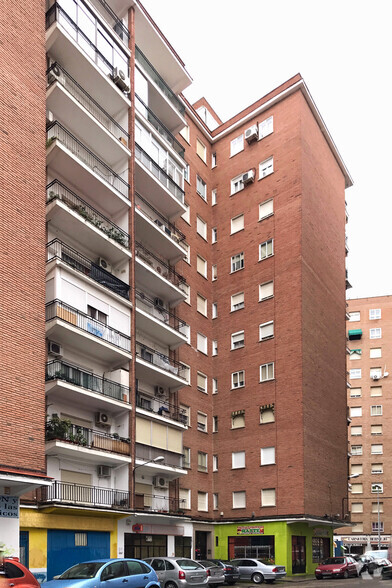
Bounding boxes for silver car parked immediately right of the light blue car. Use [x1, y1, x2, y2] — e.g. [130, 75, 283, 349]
[144, 557, 208, 588]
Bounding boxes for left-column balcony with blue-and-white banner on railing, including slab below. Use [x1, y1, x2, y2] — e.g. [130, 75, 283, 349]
[46, 300, 131, 365]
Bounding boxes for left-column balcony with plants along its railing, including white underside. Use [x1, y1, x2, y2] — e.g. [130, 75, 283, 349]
[46, 180, 131, 265]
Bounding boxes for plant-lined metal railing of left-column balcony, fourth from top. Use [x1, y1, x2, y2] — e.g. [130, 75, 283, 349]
[46, 180, 129, 249]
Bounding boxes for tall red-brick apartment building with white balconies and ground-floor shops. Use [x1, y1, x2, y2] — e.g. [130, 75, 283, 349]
[0, 0, 351, 578]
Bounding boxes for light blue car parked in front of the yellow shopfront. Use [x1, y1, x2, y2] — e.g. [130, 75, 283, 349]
[41, 559, 160, 588]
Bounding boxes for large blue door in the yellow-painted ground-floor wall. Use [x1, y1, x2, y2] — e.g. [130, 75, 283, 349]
[47, 529, 110, 580]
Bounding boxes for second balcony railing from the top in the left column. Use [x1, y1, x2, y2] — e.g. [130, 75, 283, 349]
[46, 63, 129, 140]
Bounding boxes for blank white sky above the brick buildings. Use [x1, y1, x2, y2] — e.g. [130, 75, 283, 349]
[142, 0, 392, 298]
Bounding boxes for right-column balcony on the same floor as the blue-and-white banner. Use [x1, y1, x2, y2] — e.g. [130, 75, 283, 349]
[136, 341, 188, 390]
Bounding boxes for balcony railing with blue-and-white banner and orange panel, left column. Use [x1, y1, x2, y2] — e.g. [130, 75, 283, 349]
[46, 300, 131, 353]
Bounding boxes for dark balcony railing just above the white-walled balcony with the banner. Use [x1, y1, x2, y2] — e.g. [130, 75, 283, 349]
[46, 239, 129, 300]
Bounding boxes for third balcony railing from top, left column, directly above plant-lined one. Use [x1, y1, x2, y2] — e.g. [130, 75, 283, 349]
[46, 121, 129, 198]
